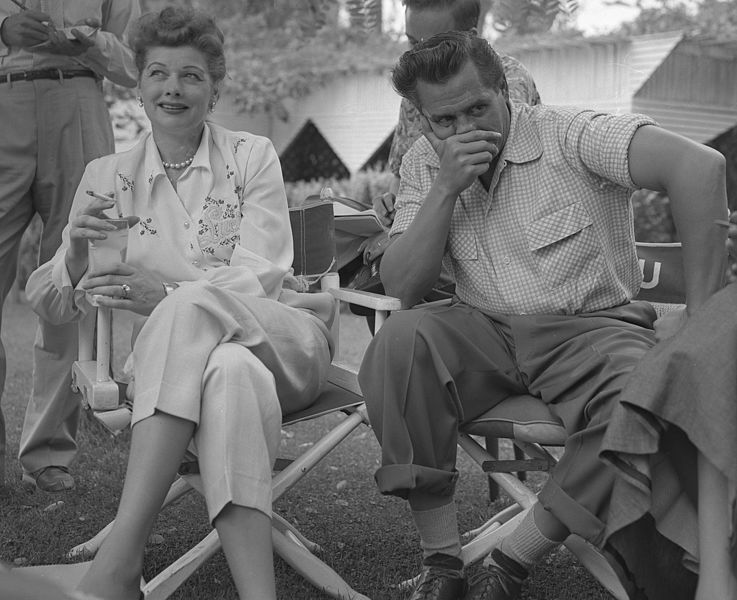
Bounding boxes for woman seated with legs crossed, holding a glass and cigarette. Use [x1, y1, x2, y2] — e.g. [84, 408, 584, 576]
[27, 7, 334, 600]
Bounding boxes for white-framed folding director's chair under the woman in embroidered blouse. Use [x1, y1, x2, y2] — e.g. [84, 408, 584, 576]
[15, 203, 400, 600]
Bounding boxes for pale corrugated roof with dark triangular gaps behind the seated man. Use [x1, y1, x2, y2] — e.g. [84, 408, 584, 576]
[208, 32, 737, 172]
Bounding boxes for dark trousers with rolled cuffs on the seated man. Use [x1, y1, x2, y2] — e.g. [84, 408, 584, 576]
[359, 302, 655, 544]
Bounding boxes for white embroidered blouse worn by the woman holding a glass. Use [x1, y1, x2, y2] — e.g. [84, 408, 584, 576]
[26, 123, 333, 323]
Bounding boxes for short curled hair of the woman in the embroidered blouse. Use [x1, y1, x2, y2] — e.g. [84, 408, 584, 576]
[130, 6, 226, 84]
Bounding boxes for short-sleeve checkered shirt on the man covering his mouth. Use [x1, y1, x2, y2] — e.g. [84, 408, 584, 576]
[391, 104, 655, 314]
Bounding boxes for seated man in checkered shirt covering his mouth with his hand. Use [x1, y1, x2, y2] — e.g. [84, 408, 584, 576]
[359, 32, 727, 600]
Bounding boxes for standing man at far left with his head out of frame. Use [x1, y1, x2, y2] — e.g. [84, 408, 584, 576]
[0, 0, 140, 492]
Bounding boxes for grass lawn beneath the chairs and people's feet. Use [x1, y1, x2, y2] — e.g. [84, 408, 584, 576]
[0, 299, 610, 600]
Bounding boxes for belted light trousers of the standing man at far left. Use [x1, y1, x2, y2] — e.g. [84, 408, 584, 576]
[0, 77, 114, 480]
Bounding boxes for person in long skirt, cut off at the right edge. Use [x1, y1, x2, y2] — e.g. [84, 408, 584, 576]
[602, 218, 737, 600]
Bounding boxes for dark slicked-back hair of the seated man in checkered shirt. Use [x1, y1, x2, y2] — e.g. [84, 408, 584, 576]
[392, 31, 509, 107]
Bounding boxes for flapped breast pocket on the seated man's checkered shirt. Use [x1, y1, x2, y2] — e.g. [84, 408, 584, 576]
[527, 202, 603, 288]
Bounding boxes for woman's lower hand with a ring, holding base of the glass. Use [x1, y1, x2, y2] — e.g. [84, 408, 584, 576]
[80, 263, 166, 316]
